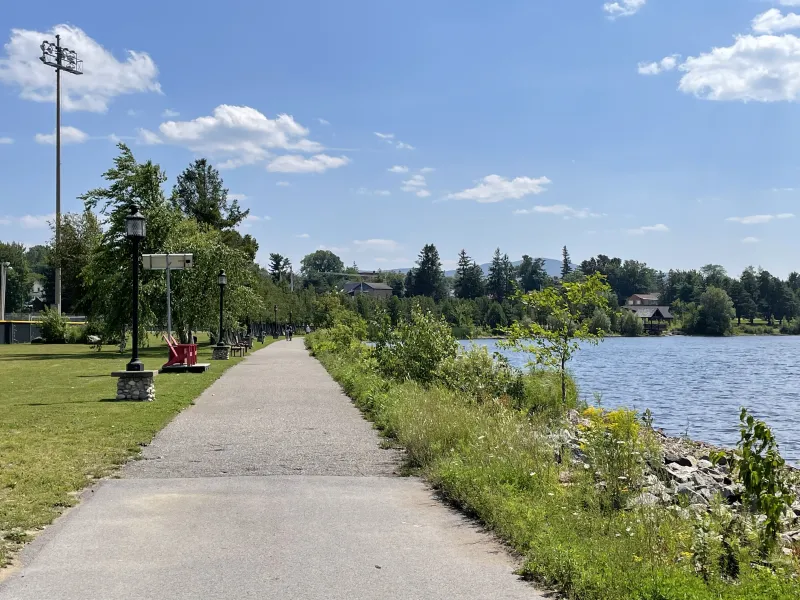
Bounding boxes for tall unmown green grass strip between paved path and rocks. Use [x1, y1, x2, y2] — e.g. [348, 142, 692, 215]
[309, 337, 800, 600]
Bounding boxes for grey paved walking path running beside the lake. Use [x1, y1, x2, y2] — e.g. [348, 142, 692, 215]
[0, 339, 542, 600]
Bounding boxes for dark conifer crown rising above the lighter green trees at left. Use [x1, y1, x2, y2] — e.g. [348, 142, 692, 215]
[172, 158, 250, 230]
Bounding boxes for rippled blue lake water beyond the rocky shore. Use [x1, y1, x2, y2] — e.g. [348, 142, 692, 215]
[468, 336, 800, 465]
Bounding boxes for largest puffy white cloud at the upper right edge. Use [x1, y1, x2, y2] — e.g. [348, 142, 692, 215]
[678, 34, 800, 102]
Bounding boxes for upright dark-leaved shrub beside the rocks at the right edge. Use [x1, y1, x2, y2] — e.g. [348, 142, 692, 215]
[733, 408, 794, 553]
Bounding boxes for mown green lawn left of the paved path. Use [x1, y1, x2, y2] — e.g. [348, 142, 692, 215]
[0, 338, 273, 565]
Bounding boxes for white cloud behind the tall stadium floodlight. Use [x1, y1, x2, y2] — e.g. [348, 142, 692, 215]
[0, 25, 161, 112]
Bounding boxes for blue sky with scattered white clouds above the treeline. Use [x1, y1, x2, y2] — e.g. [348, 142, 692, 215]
[0, 0, 800, 276]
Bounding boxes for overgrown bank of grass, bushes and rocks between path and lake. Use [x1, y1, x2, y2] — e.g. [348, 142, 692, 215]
[306, 294, 800, 600]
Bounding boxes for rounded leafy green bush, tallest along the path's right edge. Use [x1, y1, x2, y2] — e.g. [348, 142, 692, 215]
[374, 306, 458, 384]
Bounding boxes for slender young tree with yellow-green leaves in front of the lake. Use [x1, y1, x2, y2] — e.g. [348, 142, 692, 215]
[503, 274, 610, 403]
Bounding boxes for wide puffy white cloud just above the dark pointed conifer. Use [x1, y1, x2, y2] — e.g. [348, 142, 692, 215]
[159, 104, 323, 168]
